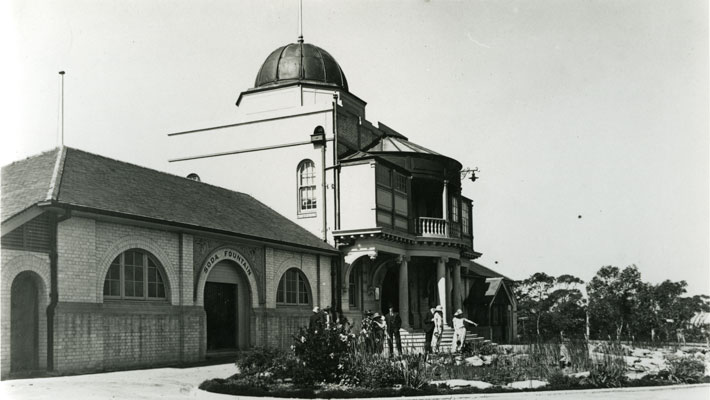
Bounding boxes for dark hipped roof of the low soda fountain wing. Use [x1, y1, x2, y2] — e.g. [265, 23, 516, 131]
[2, 147, 337, 253]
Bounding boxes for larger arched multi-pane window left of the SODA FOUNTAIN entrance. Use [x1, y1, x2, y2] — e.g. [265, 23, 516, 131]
[104, 249, 167, 300]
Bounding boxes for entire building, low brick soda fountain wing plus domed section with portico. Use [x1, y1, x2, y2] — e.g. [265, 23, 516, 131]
[0, 36, 516, 378]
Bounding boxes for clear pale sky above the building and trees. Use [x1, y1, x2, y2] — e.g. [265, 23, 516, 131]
[0, 0, 710, 294]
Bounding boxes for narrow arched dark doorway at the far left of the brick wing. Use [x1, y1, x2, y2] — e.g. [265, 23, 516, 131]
[10, 272, 39, 372]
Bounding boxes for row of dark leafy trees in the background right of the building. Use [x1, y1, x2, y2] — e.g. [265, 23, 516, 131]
[515, 265, 710, 342]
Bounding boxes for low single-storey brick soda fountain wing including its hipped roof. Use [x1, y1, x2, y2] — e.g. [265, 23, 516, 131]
[1, 148, 338, 378]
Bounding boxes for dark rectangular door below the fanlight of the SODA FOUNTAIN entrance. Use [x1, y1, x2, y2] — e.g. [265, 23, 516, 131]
[205, 282, 237, 351]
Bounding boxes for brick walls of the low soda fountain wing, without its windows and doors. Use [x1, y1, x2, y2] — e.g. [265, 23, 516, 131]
[0, 212, 331, 378]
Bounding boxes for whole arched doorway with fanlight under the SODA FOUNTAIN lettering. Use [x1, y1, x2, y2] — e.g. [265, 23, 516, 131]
[204, 260, 251, 352]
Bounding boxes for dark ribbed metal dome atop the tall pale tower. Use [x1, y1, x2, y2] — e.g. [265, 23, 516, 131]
[254, 43, 348, 90]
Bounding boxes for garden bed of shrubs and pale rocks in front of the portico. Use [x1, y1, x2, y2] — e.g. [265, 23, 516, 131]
[200, 328, 710, 398]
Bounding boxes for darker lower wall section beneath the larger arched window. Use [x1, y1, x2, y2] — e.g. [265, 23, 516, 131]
[55, 302, 204, 373]
